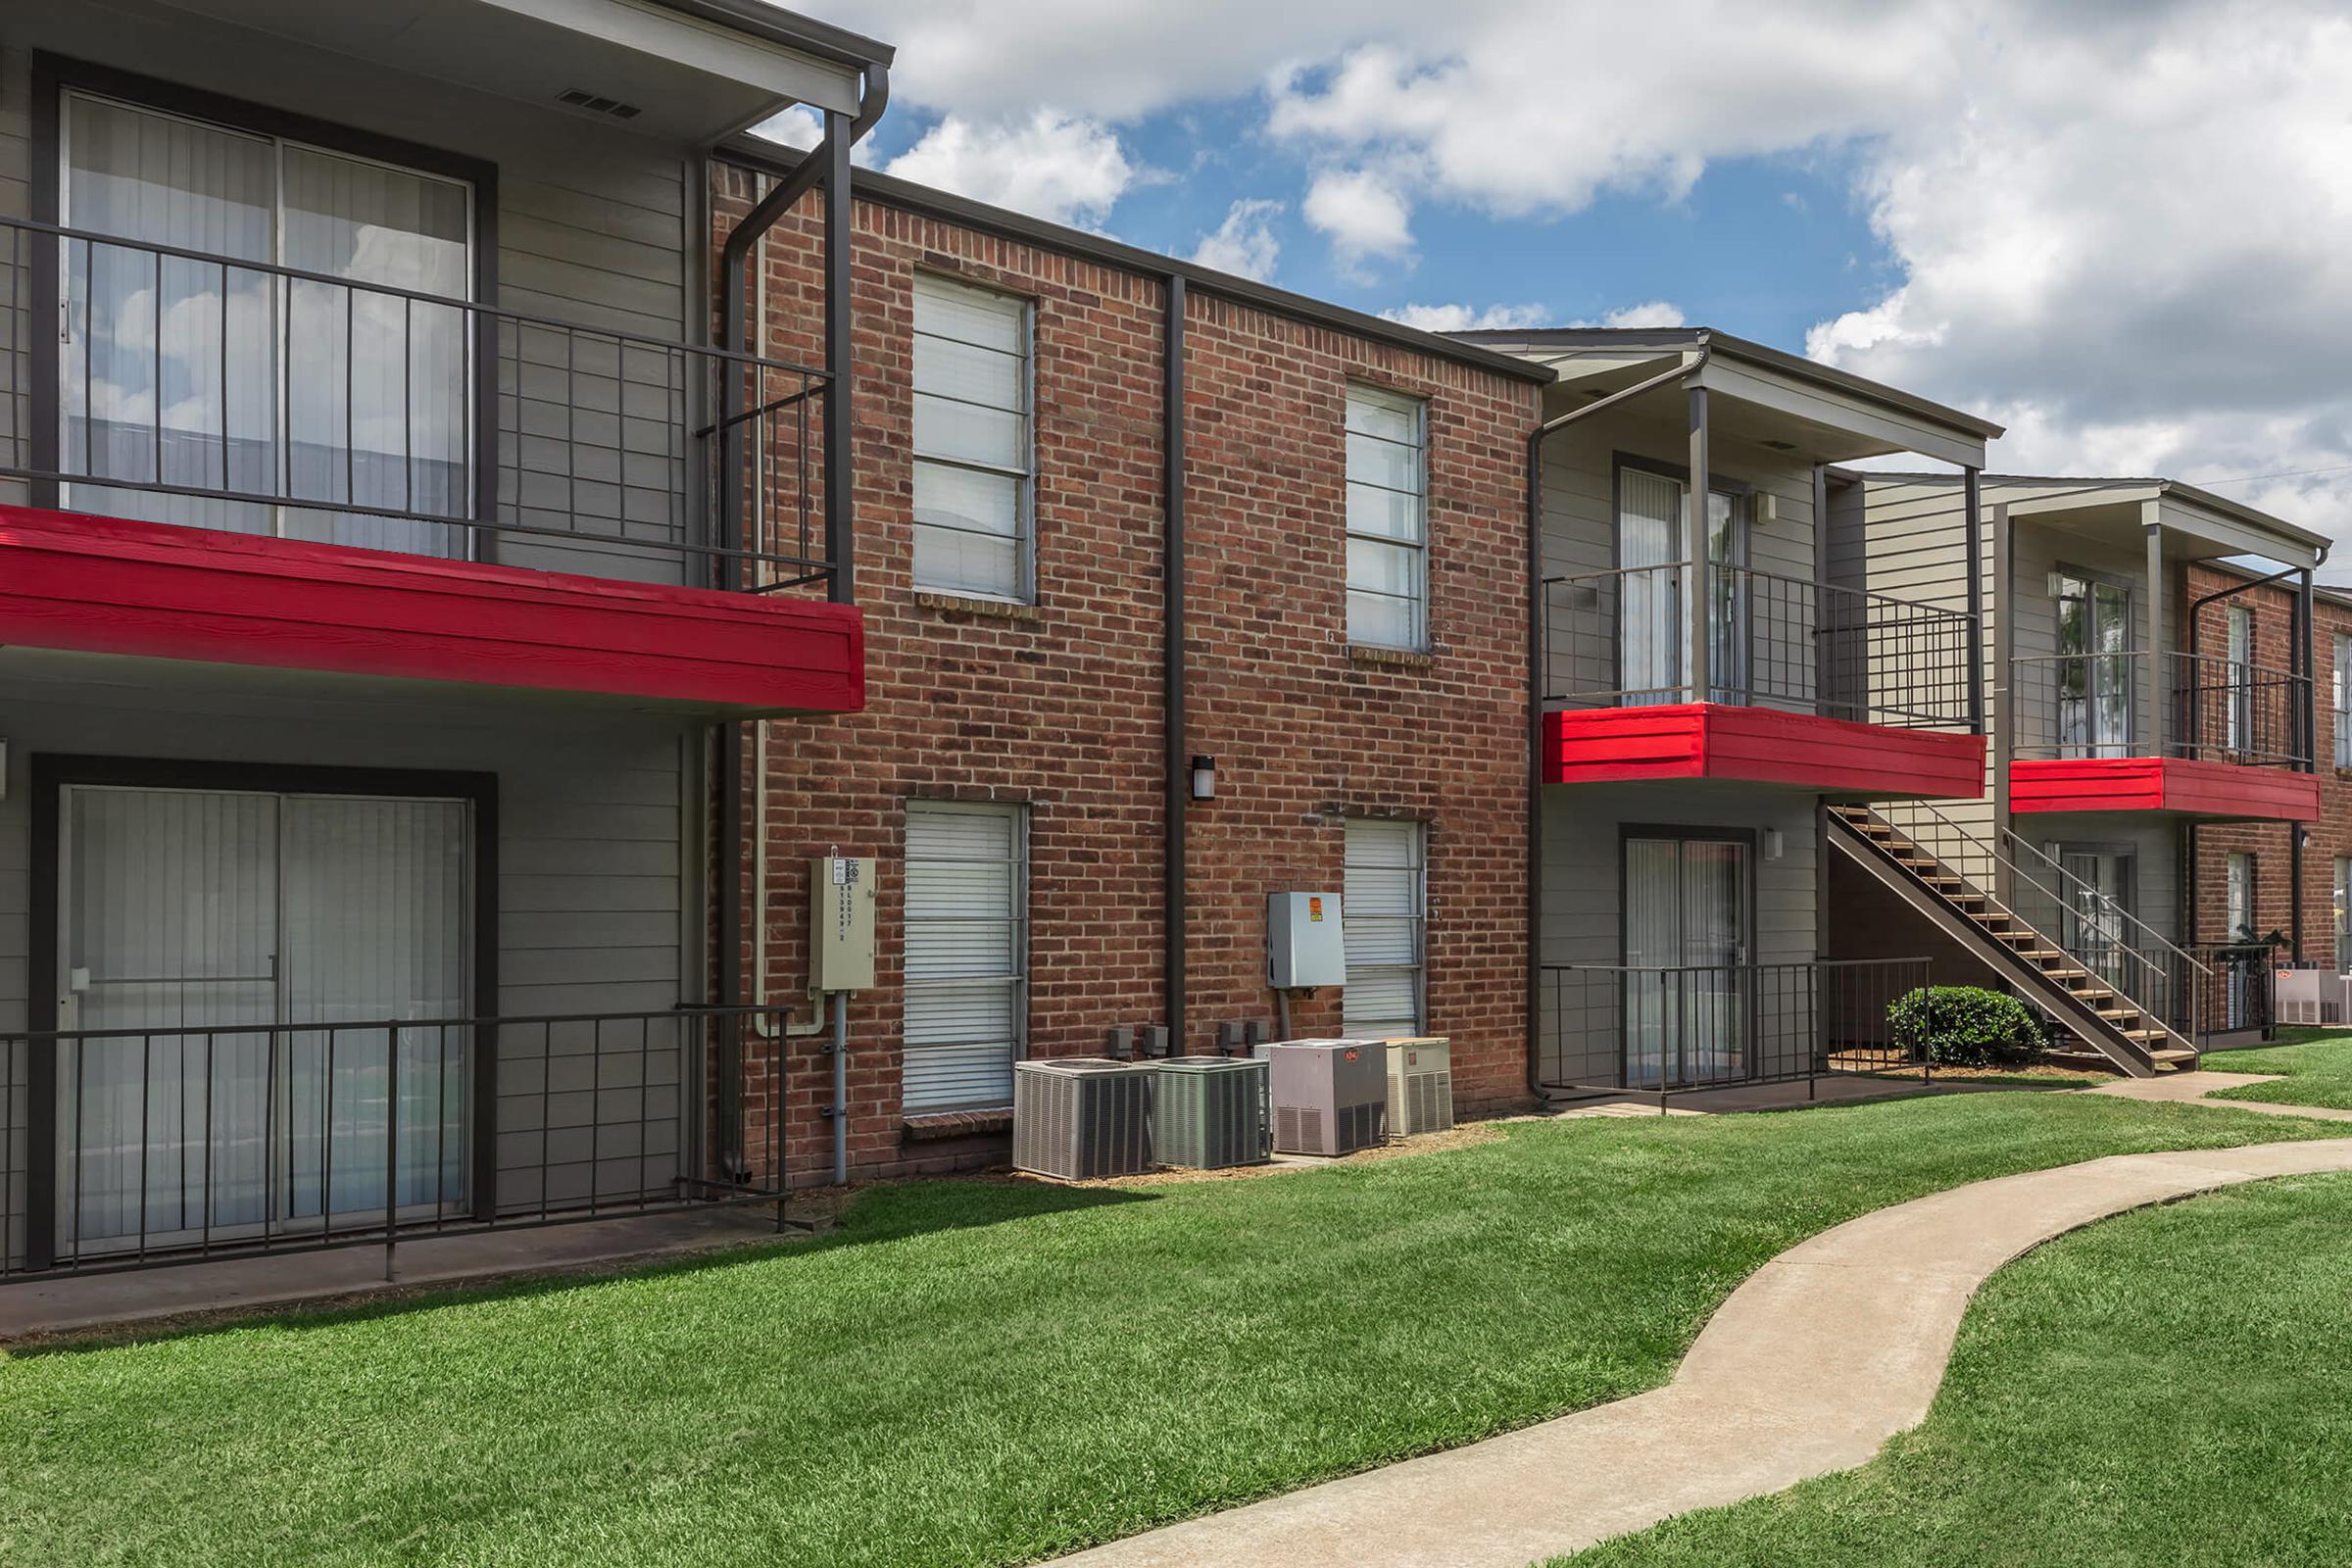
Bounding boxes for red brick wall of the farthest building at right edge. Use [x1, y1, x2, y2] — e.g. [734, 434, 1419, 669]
[2187, 566, 2352, 961]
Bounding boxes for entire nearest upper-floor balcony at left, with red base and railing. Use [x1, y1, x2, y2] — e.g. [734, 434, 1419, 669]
[0, 0, 887, 717]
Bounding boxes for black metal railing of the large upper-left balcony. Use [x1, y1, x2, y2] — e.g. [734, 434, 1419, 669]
[0, 219, 830, 590]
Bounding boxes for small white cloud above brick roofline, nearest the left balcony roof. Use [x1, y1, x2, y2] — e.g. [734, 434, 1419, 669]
[887, 108, 1143, 228]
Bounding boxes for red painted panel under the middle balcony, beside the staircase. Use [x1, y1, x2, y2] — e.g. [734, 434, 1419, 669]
[1543, 703, 1985, 800]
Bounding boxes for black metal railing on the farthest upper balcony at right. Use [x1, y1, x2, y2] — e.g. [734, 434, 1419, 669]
[2009, 651, 2312, 768]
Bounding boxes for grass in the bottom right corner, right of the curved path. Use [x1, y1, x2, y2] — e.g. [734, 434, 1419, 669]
[1562, 1175, 2352, 1568]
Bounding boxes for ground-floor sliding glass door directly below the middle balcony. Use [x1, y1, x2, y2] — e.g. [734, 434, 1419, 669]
[1623, 835, 1752, 1089]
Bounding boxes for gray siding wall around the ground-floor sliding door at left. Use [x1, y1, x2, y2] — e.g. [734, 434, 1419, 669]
[0, 674, 701, 1250]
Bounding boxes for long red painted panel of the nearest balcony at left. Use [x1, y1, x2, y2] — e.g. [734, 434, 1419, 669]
[0, 506, 865, 717]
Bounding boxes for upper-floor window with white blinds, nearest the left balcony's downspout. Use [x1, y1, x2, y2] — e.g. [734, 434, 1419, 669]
[915, 272, 1033, 600]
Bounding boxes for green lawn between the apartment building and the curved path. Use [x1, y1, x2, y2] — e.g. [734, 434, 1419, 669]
[0, 1093, 2340, 1568]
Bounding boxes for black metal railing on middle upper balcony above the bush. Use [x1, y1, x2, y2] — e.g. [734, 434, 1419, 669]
[1543, 562, 1974, 729]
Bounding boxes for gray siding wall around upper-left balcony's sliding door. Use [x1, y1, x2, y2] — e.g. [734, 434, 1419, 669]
[0, 0, 708, 581]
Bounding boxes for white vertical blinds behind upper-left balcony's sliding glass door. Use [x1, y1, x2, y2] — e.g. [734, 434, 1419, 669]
[59, 94, 472, 555]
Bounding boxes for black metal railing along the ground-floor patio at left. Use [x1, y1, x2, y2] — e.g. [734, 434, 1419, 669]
[0, 1006, 790, 1279]
